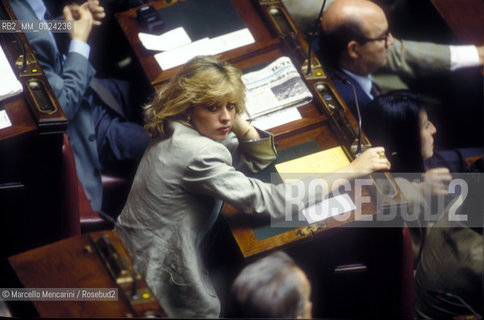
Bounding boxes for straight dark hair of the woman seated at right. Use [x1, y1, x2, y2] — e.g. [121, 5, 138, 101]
[363, 90, 438, 172]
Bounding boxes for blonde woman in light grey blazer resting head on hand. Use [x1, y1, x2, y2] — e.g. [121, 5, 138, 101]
[118, 56, 390, 317]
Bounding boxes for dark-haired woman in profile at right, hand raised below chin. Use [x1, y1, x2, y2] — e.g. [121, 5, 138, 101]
[363, 90, 482, 266]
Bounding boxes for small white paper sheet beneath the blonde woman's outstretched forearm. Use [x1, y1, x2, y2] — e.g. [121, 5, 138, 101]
[301, 193, 356, 223]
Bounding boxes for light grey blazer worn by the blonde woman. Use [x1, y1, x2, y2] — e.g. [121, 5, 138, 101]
[117, 122, 304, 317]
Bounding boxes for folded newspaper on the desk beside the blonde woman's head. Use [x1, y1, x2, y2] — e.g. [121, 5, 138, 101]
[242, 57, 313, 119]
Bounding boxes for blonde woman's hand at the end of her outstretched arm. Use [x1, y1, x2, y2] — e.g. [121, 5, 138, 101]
[338, 147, 391, 176]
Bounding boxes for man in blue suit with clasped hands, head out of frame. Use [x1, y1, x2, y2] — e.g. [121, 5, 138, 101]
[10, 0, 149, 210]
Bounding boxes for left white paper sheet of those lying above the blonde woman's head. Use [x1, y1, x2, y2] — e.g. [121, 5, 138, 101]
[138, 27, 192, 51]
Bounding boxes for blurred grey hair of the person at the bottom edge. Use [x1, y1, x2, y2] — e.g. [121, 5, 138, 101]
[227, 251, 305, 319]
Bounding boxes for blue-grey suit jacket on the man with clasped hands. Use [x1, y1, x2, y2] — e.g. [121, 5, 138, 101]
[10, 0, 102, 210]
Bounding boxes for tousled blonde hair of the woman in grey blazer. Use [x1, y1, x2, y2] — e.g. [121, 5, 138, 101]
[144, 56, 245, 138]
